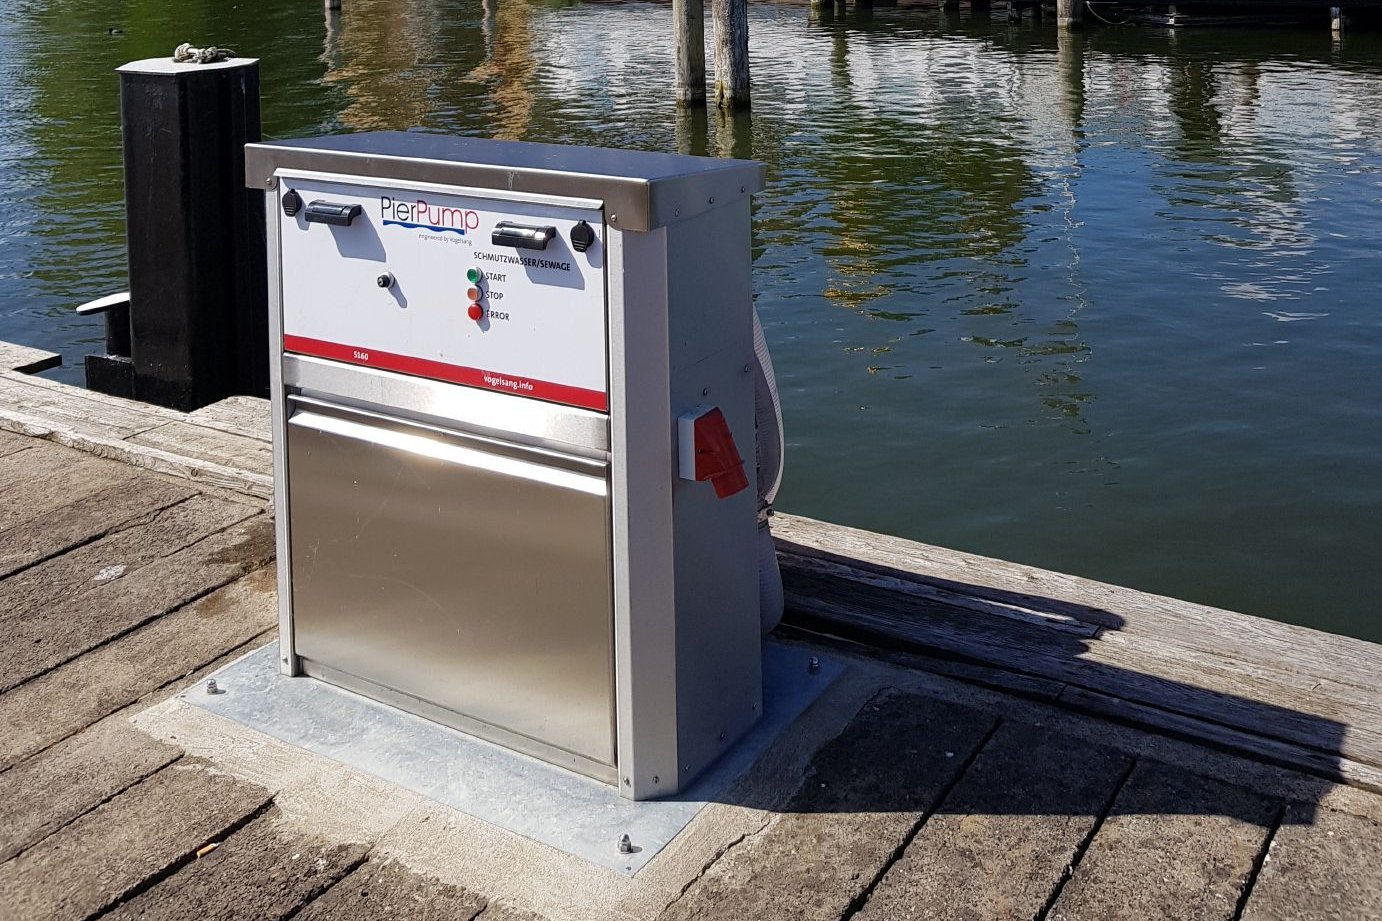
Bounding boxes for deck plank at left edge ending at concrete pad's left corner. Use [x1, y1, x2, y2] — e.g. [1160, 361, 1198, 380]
[0, 714, 182, 863]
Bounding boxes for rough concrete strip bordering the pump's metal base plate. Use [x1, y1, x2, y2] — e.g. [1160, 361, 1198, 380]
[134, 647, 878, 921]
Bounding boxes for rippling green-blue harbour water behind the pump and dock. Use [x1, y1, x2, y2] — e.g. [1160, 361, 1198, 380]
[0, 0, 1382, 640]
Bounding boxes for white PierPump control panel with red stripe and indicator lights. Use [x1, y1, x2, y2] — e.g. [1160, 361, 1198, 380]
[269, 174, 609, 412]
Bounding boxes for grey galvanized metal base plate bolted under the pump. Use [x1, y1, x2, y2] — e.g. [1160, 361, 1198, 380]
[181, 642, 844, 877]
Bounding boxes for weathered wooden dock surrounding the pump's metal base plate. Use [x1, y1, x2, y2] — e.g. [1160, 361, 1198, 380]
[0, 346, 1382, 921]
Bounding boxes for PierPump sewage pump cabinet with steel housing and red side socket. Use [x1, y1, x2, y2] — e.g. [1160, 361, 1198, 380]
[246, 133, 781, 799]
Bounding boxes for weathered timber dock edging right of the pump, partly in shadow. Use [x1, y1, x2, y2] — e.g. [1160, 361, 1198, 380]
[774, 516, 1382, 783]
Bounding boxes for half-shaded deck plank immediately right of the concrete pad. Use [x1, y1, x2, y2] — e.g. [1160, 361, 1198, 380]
[661, 691, 995, 921]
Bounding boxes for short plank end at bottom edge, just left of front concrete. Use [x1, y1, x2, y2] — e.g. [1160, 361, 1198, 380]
[293, 860, 496, 921]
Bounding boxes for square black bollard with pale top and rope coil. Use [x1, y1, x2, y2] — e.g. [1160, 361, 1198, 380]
[105, 58, 268, 409]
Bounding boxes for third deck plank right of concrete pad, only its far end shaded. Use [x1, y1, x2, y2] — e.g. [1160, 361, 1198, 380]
[1048, 762, 1280, 921]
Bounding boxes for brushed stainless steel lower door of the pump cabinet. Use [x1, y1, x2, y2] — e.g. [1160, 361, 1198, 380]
[287, 398, 615, 780]
